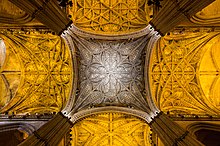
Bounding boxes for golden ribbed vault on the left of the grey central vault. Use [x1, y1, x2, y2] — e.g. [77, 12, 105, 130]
[0, 32, 72, 113]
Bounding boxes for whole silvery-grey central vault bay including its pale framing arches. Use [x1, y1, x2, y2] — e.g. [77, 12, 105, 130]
[63, 25, 158, 121]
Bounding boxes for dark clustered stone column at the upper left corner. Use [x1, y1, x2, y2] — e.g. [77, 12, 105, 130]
[9, 0, 72, 35]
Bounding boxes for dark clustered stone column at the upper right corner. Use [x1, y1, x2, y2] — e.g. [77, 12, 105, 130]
[150, 0, 215, 36]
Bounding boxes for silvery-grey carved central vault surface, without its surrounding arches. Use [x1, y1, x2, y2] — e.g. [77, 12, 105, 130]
[75, 37, 150, 110]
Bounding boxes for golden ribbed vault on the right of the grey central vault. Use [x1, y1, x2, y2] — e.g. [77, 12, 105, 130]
[150, 33, 220, 114]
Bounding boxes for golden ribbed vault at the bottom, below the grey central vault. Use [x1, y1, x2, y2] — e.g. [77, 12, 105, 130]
[71, 112, 150, 146]
